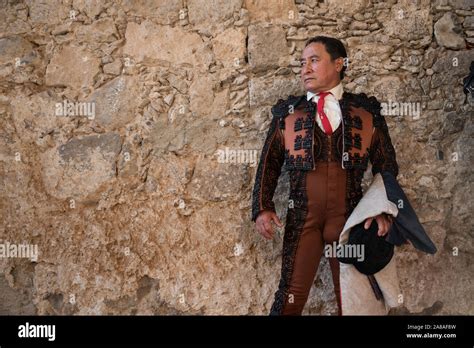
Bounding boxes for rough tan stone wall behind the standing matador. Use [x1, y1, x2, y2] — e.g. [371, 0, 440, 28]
[0, 0, 474, 315]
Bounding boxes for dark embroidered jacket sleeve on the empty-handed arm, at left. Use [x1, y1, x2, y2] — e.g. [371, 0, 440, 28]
[252, 116, 285, 221]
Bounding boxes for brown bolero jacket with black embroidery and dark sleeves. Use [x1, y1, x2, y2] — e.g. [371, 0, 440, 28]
[252, 92, 398, 221]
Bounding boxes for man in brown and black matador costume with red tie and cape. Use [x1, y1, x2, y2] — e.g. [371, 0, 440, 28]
[252, 36, 436, 315]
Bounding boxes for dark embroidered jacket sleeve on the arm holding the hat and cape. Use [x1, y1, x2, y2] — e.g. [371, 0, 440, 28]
[369, 102, 398, 178]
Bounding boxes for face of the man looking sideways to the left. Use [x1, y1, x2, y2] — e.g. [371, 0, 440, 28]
[301, 42, 344, 93]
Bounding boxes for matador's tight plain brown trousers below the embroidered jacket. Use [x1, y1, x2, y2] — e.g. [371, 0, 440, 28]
[282, 161, 346, 315]
